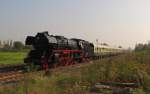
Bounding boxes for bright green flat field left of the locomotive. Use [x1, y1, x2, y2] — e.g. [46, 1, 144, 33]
[0, 52, 27, 65]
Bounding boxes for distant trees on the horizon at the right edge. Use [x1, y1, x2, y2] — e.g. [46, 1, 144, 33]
[135, 42, 150, 51]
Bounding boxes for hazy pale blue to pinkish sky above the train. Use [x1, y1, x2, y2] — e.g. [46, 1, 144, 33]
[0, 0, 150, 48]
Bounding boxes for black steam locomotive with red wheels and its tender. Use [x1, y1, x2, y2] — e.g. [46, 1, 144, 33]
[24, 32, 94, 69]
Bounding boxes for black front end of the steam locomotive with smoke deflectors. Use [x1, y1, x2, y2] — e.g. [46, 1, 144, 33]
[24, 32, 57, 65]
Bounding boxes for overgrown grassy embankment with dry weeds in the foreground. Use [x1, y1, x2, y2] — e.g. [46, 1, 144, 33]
[0, 51, 150, 94]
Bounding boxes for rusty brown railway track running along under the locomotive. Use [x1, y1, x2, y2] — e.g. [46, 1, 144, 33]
[0, 62, 92, 85]
